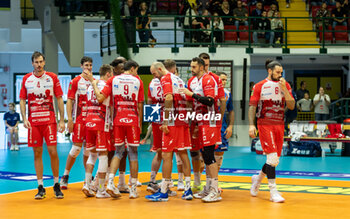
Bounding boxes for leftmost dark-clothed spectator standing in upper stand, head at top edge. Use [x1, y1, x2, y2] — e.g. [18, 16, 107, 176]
[120, 0, 137, 47]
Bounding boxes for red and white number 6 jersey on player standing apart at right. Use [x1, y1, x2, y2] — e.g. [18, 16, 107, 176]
[249, 79, 293, 123]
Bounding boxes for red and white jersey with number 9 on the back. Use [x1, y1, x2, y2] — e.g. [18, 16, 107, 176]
[101, 74, 145, 126]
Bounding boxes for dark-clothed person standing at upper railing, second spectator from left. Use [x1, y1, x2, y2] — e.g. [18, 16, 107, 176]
[136, 2, 151, 47]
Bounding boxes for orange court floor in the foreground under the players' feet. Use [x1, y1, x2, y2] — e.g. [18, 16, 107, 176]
[0, 173, 350, 219]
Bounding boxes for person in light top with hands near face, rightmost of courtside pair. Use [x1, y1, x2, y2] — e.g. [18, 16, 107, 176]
[314, 87, 331, 121]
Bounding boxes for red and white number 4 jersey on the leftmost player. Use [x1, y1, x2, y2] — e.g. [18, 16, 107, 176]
[19, 72, 63, 126]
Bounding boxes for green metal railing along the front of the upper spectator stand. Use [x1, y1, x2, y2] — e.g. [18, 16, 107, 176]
[100, 15, 350, 54]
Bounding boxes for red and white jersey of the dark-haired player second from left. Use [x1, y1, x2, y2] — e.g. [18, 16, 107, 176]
[67, 75, 91, 123]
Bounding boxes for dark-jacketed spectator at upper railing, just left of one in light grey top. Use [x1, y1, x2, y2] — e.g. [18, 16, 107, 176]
[253, 11, 275, 46]
